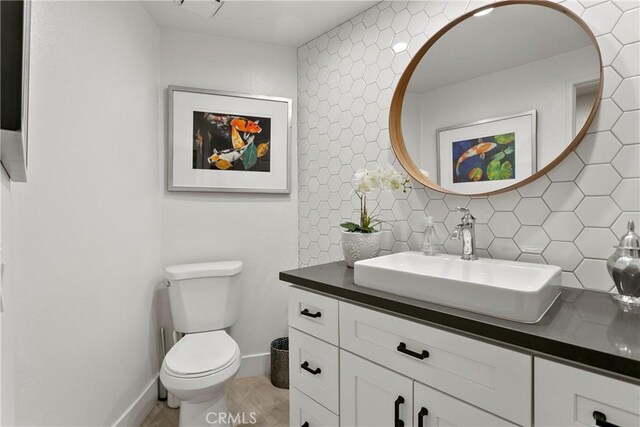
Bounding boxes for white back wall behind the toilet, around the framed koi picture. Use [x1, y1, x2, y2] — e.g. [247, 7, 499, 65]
[160, 30, 298, 375]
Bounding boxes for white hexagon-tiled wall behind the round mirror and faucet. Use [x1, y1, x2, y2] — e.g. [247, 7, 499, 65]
[298, 0, 640, 291]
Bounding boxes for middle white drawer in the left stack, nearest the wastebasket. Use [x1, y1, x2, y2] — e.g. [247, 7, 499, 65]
[289, 328, 339, 414]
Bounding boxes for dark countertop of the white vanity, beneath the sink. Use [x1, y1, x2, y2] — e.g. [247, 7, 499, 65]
[280, 262, 640, 382]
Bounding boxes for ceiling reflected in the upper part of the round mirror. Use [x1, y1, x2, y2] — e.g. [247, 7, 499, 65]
[407, 5, 596, 93]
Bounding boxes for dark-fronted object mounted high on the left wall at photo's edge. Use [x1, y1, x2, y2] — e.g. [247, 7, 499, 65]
[0, 0, 31, 182]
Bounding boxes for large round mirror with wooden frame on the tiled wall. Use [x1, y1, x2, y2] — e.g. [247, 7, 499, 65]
[390, 1, 602, 195]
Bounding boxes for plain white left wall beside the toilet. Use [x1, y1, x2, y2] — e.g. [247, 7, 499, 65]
[2, 1, 162, 425]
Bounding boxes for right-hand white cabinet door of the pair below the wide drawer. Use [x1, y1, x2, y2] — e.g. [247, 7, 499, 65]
[413, 383, 517, 427]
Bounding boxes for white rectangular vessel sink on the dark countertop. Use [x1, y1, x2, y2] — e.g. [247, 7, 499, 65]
[354, 252, 562, 323]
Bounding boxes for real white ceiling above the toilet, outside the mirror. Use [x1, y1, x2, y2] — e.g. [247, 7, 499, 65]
[141, 0, 379, 47]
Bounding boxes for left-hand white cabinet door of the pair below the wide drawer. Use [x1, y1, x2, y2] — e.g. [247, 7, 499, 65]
[340, 351, 413, 427]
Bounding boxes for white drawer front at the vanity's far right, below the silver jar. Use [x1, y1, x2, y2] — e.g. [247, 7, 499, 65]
[534, 357, 640, 427]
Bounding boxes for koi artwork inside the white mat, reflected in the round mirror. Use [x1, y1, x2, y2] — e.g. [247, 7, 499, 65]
[451, 132, 516, 183]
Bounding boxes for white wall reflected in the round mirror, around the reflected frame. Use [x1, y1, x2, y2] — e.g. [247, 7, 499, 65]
[410, 47, 599, 179]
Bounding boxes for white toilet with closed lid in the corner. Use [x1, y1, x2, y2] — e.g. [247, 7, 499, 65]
[160, 261, 242, 427]
